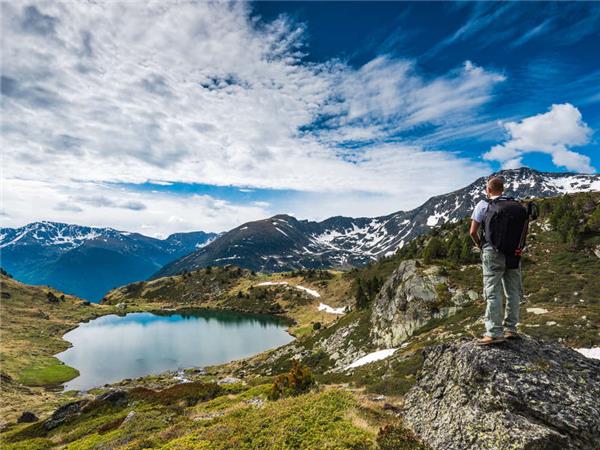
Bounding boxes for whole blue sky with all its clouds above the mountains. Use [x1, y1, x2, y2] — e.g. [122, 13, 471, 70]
[1, 2, 600, 236]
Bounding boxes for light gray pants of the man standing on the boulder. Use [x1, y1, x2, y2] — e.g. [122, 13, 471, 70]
[481, 246, 523, 338]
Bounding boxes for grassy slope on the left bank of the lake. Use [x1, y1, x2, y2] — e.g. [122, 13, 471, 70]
[0, 276, 120, 426]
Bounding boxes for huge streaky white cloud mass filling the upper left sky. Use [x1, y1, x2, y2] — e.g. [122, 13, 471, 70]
[0, 2, 504, 236]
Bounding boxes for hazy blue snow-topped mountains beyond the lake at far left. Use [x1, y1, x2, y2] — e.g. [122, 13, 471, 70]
[0, 222, 216, 301]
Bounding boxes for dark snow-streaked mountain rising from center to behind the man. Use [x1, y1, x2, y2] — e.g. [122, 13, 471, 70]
[155, 168, 600, 277]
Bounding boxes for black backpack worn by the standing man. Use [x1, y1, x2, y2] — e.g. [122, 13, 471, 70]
[483, 197, 537, 269]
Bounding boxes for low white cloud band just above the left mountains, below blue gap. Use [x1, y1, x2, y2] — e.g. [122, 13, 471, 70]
[2, 179, 270, 237]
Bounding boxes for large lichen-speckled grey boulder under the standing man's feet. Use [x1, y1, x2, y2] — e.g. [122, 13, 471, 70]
[404, 337, 600, 450]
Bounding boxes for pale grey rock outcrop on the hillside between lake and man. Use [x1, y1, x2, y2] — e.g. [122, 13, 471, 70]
[371, 260, 479, 347]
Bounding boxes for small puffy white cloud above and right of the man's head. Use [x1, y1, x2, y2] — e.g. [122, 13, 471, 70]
[484, 103, 594, 173]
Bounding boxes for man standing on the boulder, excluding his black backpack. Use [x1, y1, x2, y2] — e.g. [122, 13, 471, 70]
[469, 177, 523, 345]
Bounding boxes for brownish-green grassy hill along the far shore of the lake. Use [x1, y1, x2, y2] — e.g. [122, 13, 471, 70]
[103, 266, 352, 336]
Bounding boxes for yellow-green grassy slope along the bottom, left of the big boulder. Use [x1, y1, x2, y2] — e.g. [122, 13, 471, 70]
[3, 376, 426, 449]
